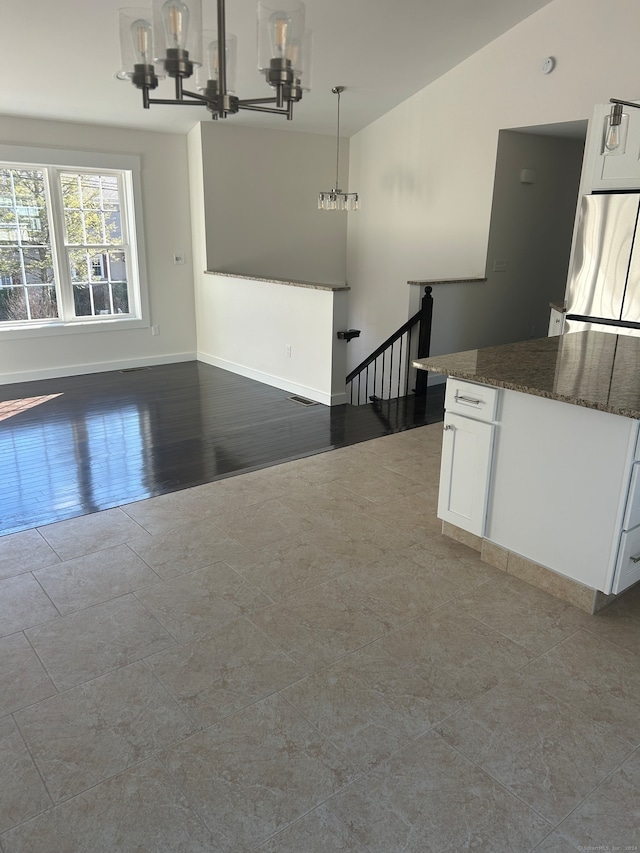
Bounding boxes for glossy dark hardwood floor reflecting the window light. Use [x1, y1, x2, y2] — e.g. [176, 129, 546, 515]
[0, 361, 443, 535]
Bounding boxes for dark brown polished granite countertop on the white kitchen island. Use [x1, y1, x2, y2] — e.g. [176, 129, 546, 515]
[413, 332, 640, 419]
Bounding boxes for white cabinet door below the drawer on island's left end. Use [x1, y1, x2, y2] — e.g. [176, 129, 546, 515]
[438, 412, 495, 536]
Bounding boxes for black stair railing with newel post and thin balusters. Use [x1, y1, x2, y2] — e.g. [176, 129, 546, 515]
[346, 285, 433, 405]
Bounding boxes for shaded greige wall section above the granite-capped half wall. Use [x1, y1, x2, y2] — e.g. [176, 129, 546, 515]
[200, 120, 348, 284]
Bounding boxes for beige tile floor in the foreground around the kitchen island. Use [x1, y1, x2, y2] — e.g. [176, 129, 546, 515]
[0, 424, 640, 853]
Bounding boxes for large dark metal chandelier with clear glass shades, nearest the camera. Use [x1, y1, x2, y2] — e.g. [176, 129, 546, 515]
[116, 0, 311, 120]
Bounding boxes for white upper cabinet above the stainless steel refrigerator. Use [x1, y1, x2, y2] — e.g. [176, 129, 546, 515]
[581, 104, 640, 194]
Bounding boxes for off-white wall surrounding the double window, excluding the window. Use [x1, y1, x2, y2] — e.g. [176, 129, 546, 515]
[0, 116, 196, 382]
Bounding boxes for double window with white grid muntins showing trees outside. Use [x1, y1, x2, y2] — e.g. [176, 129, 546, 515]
[0, 146, 146, 333]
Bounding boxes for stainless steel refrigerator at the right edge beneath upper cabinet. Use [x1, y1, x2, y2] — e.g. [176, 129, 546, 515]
[564, 192, 640, 336]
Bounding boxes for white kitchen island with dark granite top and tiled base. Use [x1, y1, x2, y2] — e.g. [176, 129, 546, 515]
[414, 332, 640, 612]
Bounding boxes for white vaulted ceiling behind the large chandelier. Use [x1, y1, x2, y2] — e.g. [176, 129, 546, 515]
[0, 0, 550, 136]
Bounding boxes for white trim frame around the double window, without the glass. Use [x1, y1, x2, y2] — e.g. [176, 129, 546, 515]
[0, 145, 151, 341]
